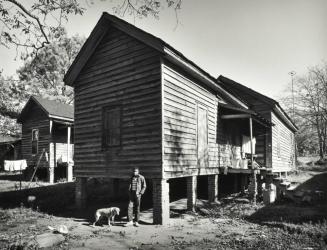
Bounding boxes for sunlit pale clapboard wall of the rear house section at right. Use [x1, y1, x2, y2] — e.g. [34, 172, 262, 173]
[271, 112, 295, 171]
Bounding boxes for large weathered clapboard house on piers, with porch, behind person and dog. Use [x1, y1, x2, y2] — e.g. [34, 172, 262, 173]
[64, 13, 298, 223]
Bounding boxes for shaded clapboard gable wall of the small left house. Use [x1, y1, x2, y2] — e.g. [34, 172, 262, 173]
[22, 105, 50, 167]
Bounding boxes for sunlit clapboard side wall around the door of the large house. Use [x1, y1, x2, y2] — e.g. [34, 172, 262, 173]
[162, 62, 218, 178]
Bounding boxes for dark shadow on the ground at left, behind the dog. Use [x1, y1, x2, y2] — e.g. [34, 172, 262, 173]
[0, 182, 156, 223]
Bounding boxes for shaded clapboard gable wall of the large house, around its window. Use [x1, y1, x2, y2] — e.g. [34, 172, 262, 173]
[74, 27, 162, 178]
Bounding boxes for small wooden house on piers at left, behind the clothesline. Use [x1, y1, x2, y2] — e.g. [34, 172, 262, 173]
[17, 96, 74, 183]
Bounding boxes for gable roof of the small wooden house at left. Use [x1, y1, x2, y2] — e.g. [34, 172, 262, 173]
[17, 96, 74, 123]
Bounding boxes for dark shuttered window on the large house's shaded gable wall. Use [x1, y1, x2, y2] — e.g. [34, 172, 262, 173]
[103, 107, 121, 147]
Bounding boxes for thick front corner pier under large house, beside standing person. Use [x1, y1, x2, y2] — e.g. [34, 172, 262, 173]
[152, 179, 169, 225]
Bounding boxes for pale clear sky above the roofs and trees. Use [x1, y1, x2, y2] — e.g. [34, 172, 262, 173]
[0, 0, 327, 98]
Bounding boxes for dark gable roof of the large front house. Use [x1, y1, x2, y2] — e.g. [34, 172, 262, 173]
[64, 12, 248, 108]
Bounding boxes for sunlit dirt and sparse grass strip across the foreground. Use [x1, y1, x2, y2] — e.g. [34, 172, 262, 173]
[0, 201, 327, 250]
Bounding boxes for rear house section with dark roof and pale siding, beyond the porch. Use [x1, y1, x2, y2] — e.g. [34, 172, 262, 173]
[217, 76, 298, 173]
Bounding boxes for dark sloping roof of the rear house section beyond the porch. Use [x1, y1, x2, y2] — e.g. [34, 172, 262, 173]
[217, 75, 298, 132]
